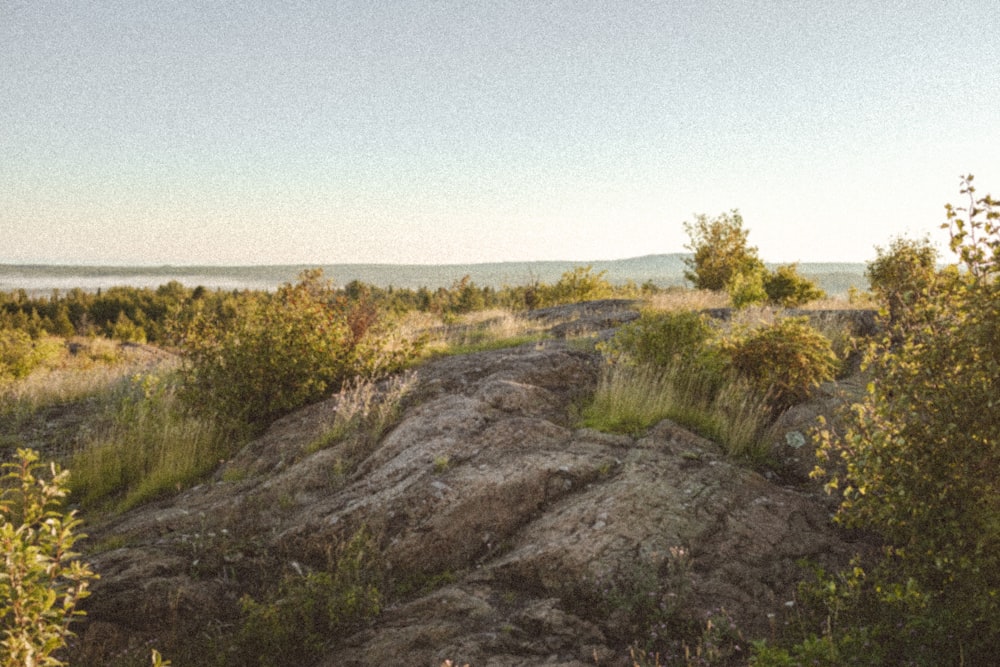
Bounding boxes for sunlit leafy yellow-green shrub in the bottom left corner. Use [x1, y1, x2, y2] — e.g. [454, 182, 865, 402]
[0, 449, 96, 667]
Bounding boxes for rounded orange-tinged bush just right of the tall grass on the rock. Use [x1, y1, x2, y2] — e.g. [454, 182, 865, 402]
[722, 317, 839, 414]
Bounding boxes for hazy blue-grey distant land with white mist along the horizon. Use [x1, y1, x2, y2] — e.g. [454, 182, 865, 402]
[0, 254, 868, 296]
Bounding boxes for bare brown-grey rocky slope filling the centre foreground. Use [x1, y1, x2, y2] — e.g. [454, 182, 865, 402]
[70, 303, 876, 667]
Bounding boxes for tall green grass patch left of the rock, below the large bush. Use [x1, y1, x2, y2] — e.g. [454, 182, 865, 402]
[69, 374, 230, 511]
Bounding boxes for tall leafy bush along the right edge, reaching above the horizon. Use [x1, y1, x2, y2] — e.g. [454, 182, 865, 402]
[817, 177, 1000, 665]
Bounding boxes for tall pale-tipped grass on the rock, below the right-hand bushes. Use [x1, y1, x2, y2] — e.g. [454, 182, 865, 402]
[581, 363, 771, 459]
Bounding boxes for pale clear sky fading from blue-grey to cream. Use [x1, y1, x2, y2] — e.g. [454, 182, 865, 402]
[0, 0, 1000, 265]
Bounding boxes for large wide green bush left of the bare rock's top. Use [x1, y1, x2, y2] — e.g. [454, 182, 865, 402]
[181, 270, 415, 428]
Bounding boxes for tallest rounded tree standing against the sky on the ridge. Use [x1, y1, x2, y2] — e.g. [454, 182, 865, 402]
[684, 209, 764, 291]
